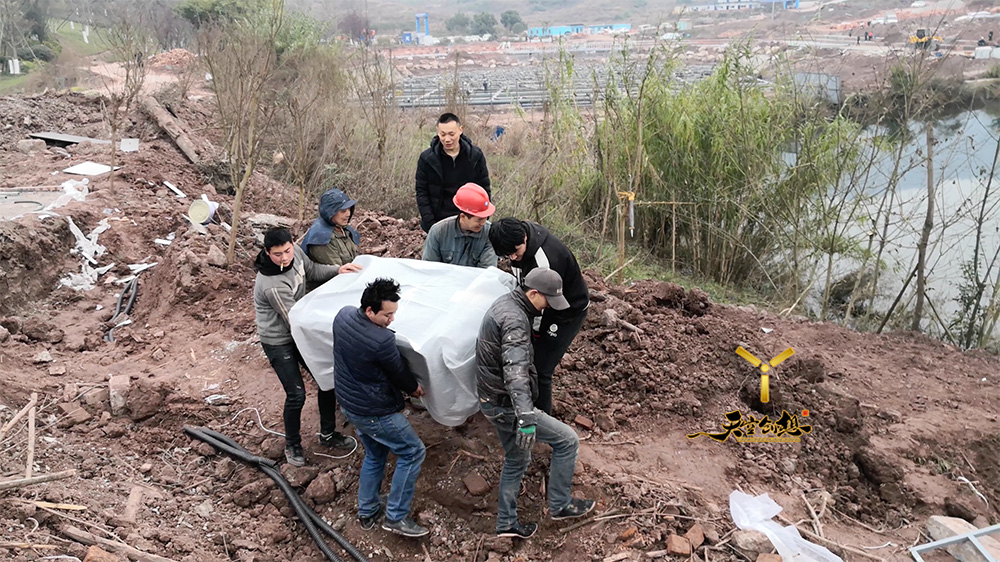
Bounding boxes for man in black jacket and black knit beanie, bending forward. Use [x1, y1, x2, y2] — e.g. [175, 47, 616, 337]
[490, 218, 590, 415]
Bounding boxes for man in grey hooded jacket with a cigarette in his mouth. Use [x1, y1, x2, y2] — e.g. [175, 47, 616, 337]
[253, 224, 361, 466]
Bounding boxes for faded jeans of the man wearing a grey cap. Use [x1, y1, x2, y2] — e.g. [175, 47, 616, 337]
[479, 400, 580, 532]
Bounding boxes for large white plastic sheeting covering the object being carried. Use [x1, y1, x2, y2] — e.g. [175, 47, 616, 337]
[289, 256, 515, 426]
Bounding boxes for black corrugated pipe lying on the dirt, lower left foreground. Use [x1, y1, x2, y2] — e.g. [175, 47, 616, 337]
[184, 426, 369, 562]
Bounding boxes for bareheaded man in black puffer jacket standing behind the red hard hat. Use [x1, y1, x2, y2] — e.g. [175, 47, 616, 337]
[416, 113, 491, 232]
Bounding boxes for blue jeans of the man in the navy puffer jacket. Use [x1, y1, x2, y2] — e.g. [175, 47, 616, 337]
[340, 408, 426, 521]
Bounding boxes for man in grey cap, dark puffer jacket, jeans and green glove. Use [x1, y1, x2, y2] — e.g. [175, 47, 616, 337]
[476, 268, 594, 539]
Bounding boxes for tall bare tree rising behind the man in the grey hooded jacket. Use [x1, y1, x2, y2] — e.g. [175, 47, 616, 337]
[198, 0, 284, 265]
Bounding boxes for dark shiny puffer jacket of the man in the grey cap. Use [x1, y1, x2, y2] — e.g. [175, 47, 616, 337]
[476, 289, 539, 427]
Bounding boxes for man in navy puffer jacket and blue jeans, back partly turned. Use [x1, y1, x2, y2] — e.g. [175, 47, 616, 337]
[333, 279, 429, 537]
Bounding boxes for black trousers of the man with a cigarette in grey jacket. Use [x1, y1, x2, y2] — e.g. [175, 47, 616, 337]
[260, 343, 337, 447]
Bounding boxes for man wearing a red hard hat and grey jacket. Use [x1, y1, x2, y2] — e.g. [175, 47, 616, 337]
[424, 179, 497, 267]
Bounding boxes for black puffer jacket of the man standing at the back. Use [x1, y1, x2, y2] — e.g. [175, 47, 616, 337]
[416, 135, 492, 232]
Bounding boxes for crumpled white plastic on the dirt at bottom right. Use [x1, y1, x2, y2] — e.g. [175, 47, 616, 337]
[729, 490, 842, 562]
